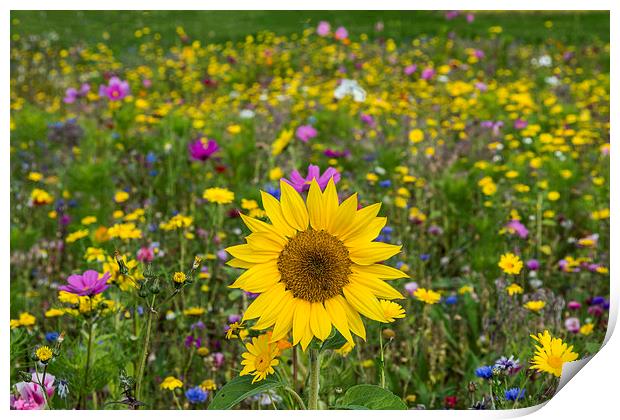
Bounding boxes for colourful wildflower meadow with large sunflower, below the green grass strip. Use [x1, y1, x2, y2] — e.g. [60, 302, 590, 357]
[8, 11, 610, 410]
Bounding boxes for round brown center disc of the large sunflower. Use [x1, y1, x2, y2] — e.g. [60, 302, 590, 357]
[278, 229, 351, 302]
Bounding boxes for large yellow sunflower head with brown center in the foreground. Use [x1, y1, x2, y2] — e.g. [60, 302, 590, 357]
[226, 180, 408, 350]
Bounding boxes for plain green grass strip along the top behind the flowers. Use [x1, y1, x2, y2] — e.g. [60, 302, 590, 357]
[11, 10, 610, 52]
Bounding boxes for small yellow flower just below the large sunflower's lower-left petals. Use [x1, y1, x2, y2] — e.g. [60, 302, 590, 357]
[239, 334, 280, 383]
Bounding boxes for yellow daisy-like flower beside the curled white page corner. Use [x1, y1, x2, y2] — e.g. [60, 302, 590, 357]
[530, 331, 579, 378]
